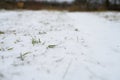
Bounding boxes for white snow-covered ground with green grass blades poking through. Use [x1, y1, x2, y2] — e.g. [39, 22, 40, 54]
[0, 10, 120, 80]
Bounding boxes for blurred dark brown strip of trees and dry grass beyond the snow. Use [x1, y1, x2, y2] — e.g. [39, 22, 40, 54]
[0, 0, 120, 11]
